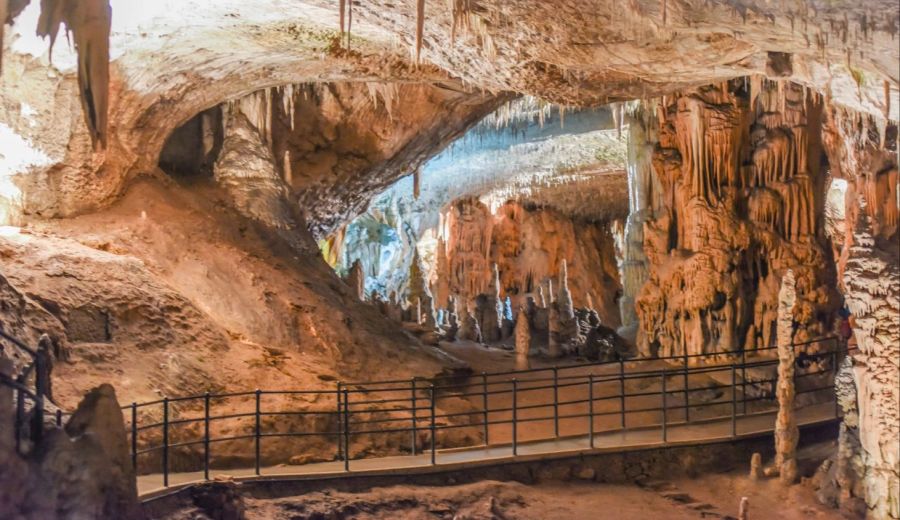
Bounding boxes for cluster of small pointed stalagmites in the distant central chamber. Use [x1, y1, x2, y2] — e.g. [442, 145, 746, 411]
[345, 253, 630, 360]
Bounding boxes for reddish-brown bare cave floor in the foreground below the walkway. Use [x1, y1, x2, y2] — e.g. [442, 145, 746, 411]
[165, 443, 854, 520]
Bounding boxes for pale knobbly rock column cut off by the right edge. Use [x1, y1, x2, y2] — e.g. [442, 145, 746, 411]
[824, 102, 900, 519]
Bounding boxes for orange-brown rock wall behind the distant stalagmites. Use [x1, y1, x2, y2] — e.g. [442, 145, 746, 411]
[433, 198, 621, 327]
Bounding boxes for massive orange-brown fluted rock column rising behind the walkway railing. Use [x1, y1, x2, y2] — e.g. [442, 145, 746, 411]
[636, 78, 840, 355]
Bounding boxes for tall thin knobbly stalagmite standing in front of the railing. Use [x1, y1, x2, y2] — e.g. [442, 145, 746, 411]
[775, 269, 800, 484]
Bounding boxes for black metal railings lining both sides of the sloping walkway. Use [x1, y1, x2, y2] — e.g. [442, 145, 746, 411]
[123, 337, 846, 487]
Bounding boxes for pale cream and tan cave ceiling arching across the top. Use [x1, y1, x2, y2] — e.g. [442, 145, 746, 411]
[3, 0, 900, 233]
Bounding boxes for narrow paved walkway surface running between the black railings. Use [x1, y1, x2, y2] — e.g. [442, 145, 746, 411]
[138, 402, 835, 499]
